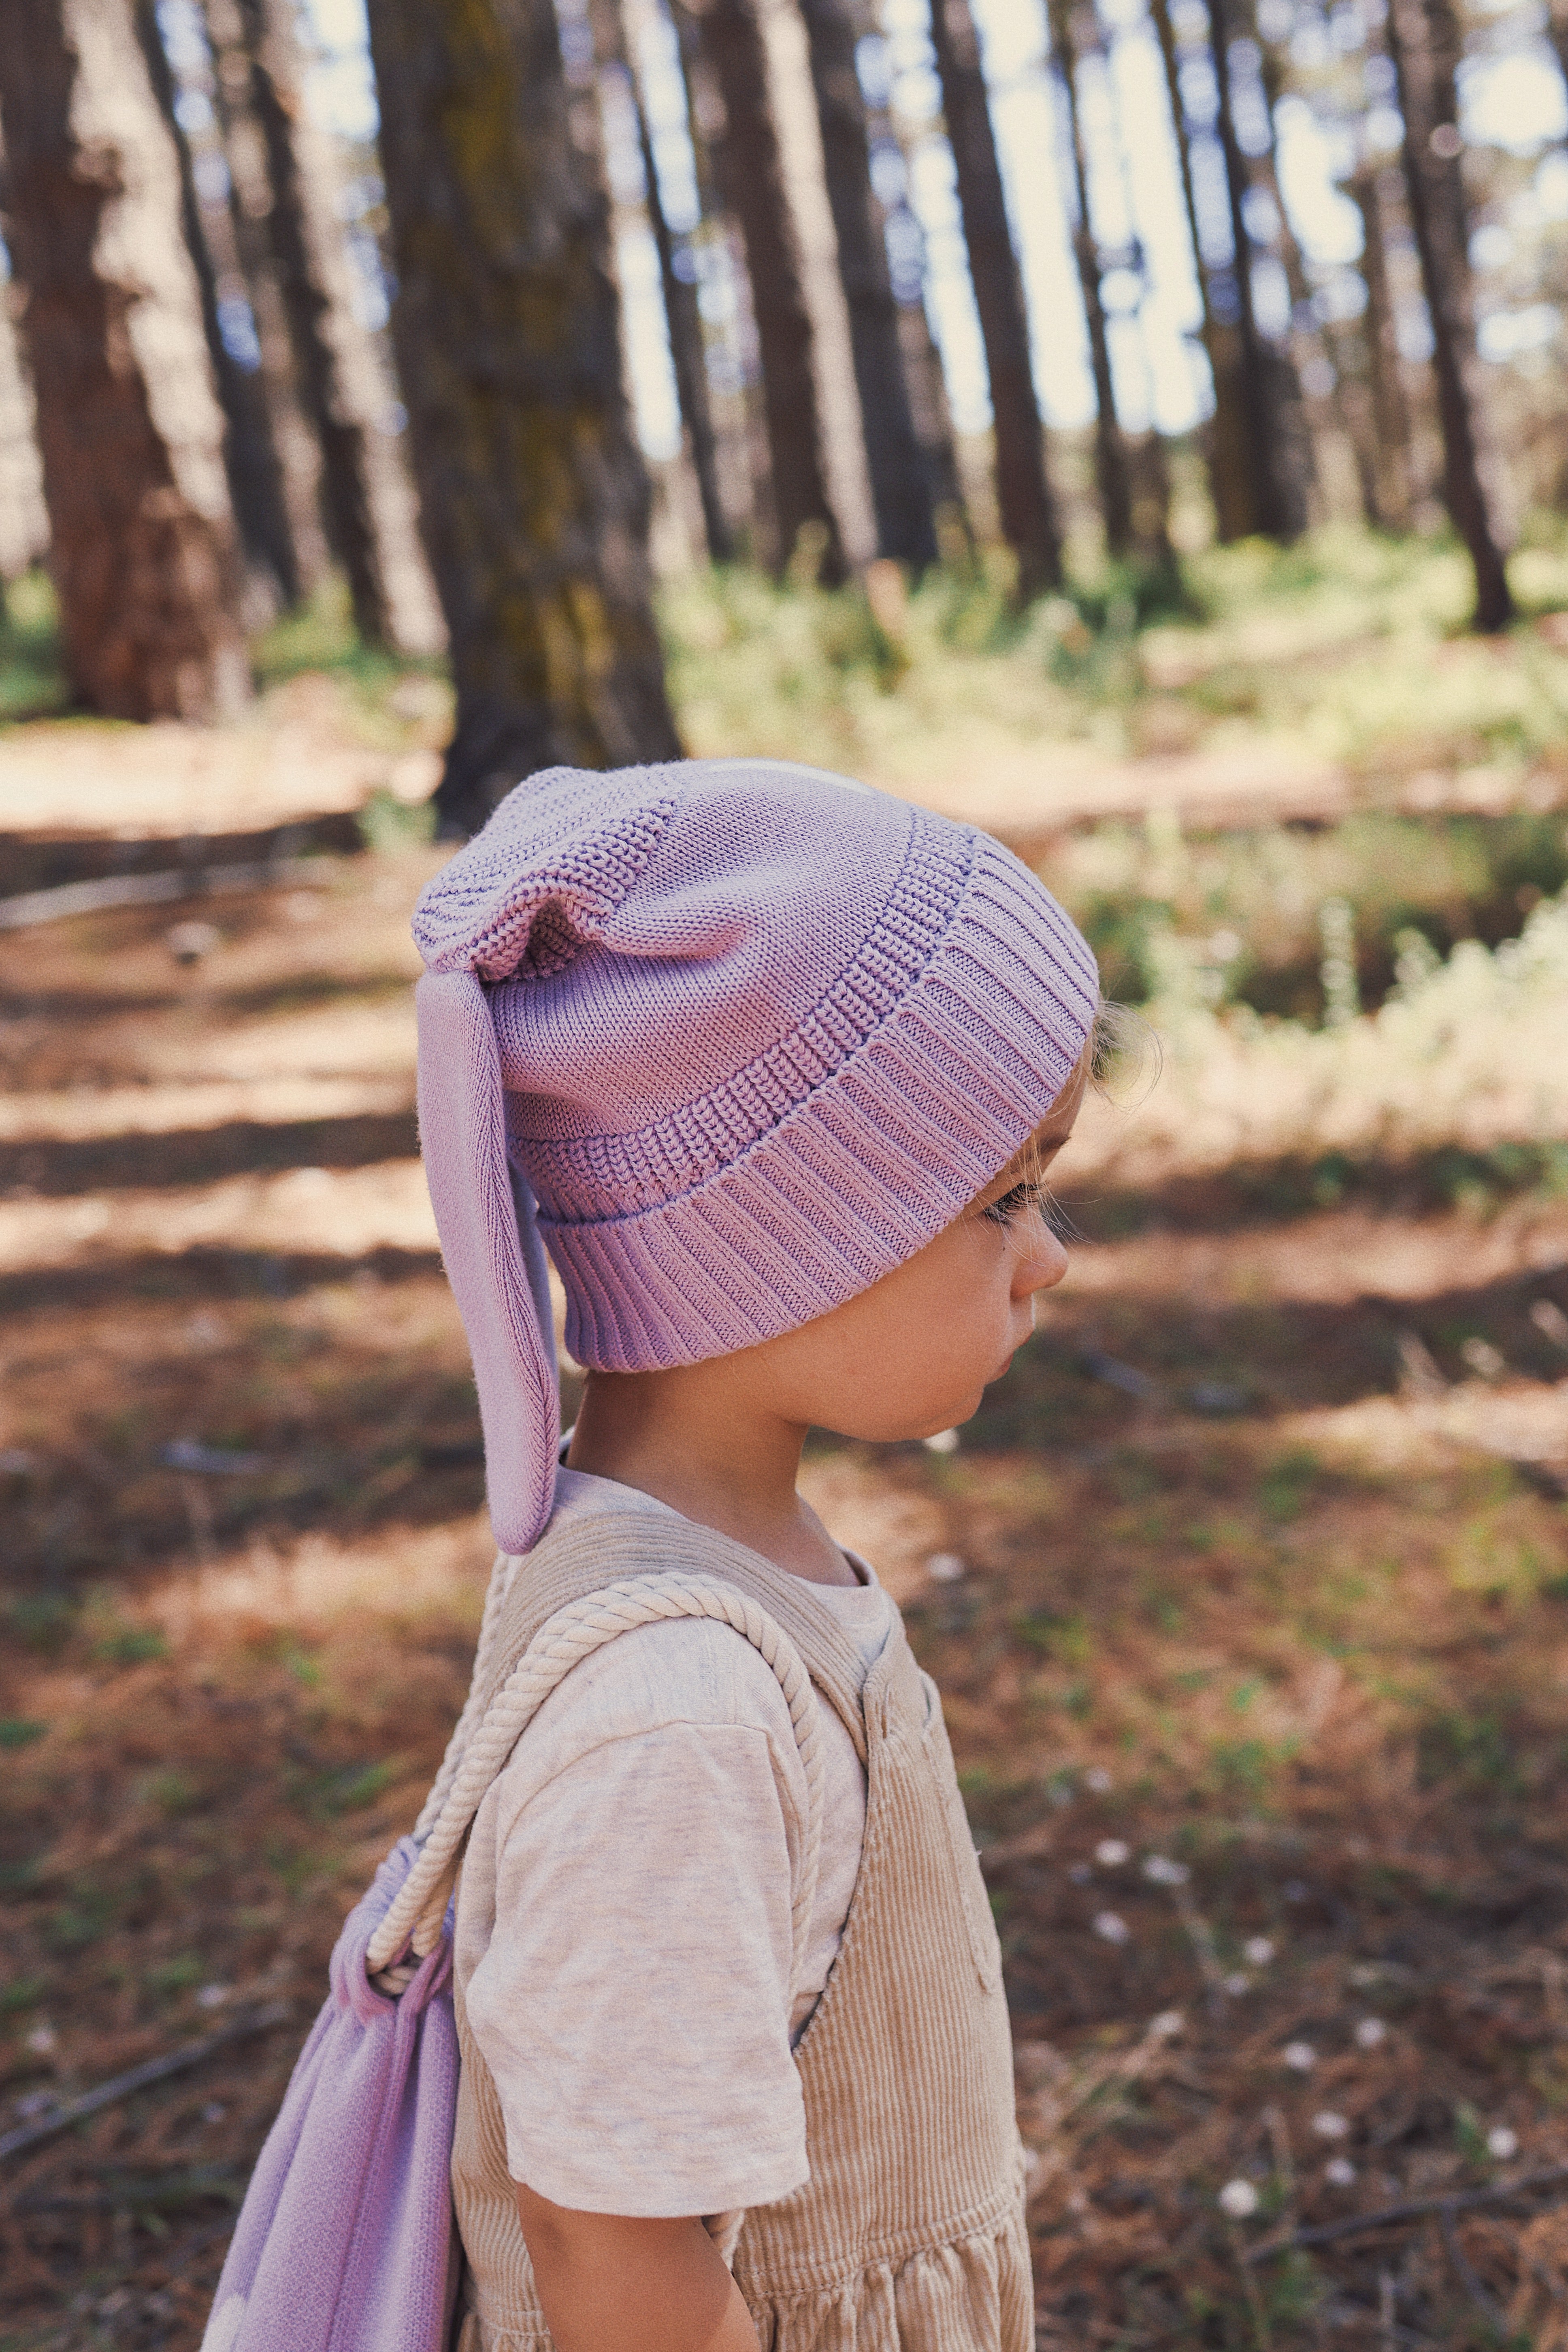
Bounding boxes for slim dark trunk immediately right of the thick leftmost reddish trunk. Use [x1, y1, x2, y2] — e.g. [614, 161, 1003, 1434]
[136, 0, 301, 607]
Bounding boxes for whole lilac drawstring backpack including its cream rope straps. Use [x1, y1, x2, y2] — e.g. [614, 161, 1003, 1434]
[202, 1552, 823, 2352]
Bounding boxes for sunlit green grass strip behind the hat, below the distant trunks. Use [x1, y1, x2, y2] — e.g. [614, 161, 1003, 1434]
[660, 524, 1568, 783]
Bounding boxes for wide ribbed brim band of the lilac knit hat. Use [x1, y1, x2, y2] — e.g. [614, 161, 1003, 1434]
[541, 835, 1098, 1371]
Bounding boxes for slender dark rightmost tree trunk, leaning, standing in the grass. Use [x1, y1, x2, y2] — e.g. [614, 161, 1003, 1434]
[1387, 0, 1514, 633]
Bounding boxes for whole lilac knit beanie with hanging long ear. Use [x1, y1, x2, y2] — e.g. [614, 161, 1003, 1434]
[414, 760, 1098, 1552]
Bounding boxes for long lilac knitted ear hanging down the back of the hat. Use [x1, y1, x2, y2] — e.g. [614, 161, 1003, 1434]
[414, 971, 562, 1552]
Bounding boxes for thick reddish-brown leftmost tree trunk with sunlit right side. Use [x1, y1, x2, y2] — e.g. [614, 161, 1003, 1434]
[0, 0, 249, 720]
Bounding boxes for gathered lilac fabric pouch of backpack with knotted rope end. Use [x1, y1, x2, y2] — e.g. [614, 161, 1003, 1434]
[202, 1837, 461, 2352]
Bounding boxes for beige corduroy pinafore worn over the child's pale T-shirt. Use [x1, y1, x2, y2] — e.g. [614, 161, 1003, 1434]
[452, 1513, 1034, 2352]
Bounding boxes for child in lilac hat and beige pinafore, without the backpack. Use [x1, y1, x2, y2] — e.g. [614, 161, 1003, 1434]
[416, 760, 1095, 2352]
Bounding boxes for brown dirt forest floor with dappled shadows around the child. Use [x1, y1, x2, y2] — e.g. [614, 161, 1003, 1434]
[0, 762, 1568, 2352]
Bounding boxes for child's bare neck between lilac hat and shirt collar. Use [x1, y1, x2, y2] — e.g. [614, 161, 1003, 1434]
[567, 1364, 858, 1585]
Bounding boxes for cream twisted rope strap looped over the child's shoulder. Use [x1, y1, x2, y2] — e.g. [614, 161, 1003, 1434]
[364, 1562, 823, 1988]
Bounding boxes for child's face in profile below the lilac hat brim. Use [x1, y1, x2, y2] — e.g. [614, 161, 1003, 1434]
[729, 1063, 1086, 1442]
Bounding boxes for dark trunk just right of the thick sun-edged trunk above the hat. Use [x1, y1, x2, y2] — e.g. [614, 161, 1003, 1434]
[799, 0, 935, 569]
